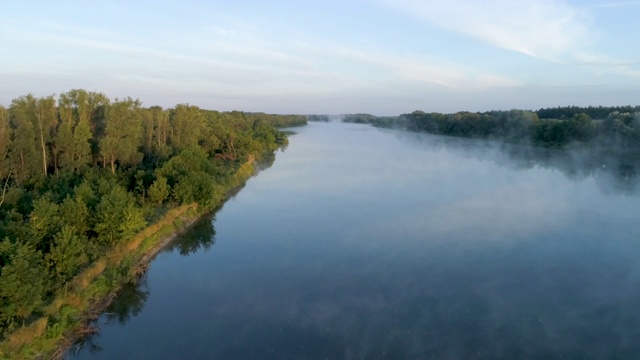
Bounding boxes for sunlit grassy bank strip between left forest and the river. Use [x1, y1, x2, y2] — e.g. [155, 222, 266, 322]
[0, 160, 256, 359]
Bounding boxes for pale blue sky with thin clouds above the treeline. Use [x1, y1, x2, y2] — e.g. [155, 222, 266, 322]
[0, 0, 640, 115]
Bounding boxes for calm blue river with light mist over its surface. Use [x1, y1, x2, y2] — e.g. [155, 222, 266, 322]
[68, 123, 640, 359]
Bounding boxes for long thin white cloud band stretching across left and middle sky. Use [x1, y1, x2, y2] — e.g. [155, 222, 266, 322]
[4, 16, 517, 95]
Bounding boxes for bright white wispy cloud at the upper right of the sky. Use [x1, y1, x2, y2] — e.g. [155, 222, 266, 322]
[381, 0, 591, 61]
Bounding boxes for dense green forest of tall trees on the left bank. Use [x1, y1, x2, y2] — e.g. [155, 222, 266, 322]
[0, 90, 306, 357]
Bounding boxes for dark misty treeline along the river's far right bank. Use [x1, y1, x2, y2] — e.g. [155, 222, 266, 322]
[308, 106, 640, 150]
